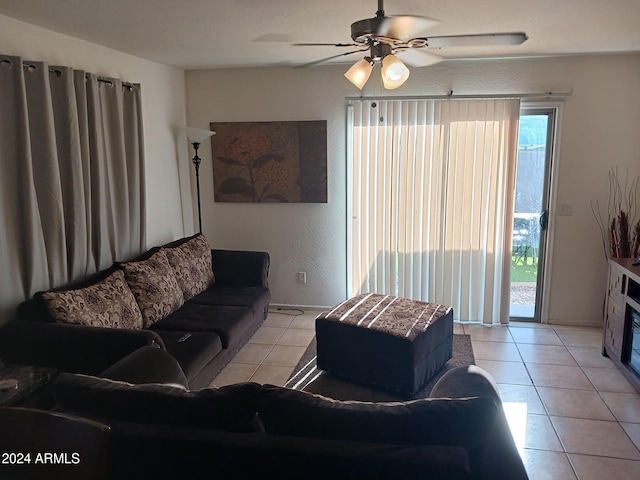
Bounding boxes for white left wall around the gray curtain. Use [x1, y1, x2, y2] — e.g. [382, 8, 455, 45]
[0, 15, 193, 246]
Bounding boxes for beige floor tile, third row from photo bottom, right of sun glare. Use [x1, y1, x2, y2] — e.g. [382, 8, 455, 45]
[538, 387, 615, 421]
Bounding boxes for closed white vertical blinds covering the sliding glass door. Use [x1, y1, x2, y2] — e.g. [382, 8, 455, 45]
[348, 99, 520, 323]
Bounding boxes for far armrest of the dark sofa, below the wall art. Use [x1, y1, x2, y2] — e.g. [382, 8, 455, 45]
[211, 250, 270, 287]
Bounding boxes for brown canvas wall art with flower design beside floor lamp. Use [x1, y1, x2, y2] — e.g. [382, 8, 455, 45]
[210, 120, 327, 203]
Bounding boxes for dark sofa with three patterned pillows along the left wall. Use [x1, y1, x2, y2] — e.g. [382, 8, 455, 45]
[0, 234, 270, 388]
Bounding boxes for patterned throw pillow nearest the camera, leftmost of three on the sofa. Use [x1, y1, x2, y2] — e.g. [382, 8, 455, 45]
[42, 270, 142, 329]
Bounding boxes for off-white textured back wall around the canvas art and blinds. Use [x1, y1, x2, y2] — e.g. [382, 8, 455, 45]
[186, 55, 640, 324]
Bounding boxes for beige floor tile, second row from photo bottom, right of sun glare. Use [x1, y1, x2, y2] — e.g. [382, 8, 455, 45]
[551, 416, 640, 460]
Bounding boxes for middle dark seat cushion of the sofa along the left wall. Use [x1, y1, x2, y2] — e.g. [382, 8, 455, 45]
[151, 302, 255, 348]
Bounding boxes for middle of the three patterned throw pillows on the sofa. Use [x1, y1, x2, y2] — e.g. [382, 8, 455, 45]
[121, 250, 184, 327]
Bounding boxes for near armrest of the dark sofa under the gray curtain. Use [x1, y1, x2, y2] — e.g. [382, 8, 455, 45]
[0, 320, 165, 375]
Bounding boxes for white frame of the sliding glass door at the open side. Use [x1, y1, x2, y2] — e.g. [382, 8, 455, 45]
[507, 101, 564, 324]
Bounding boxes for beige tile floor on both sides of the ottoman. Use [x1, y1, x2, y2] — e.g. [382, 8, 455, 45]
[213, 310, 640, 480]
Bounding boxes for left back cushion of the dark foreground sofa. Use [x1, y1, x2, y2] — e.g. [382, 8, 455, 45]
[53, 372, 260, 432]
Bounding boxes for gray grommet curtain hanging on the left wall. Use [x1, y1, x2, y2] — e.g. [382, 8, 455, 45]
[0, 54, 146, 324]
